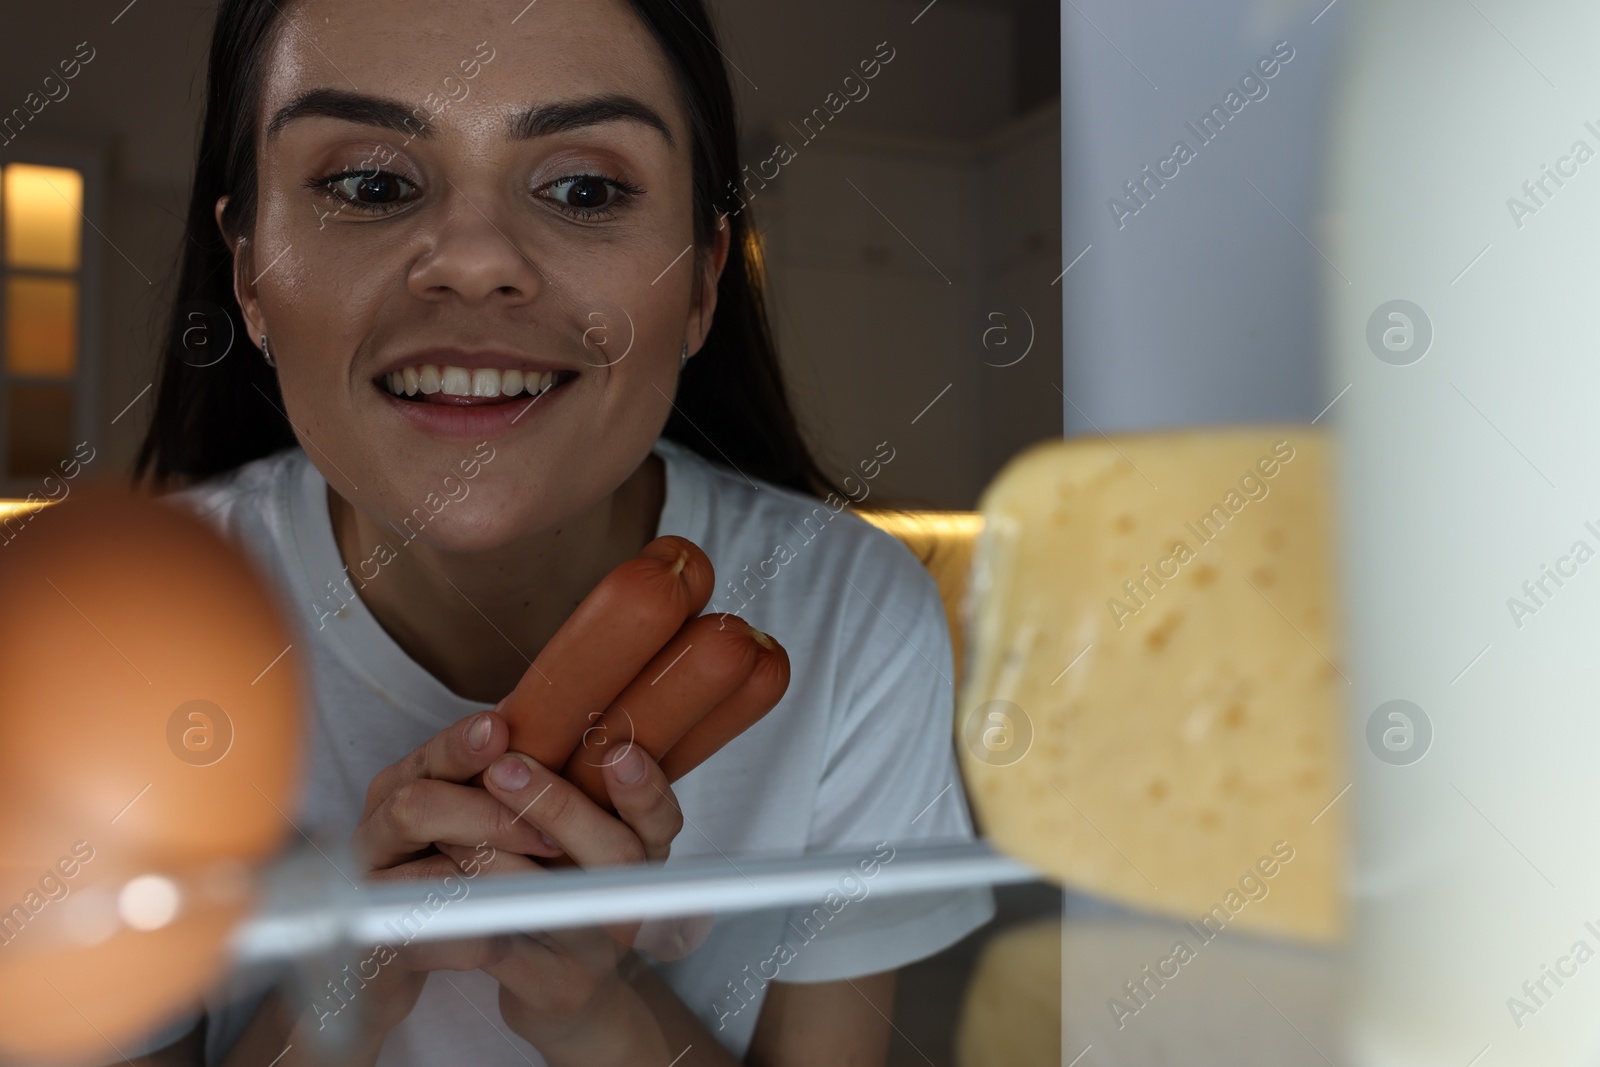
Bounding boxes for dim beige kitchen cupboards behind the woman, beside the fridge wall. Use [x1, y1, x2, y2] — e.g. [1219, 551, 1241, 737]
[752, 107, 1061, 509]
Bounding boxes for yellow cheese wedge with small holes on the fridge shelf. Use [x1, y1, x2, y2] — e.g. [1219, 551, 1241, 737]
[957, 426, 1350, 942]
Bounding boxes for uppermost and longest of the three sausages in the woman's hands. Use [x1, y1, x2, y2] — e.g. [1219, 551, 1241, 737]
[499, 536, 714, 768]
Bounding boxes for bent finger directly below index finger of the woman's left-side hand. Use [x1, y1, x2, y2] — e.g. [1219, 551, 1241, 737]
[350, 777, 560, 870]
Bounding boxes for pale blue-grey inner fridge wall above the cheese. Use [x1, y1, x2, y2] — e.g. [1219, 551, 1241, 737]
[1061, 0, 1350, 434]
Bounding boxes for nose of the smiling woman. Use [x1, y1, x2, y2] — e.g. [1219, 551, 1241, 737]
[408, 186, 544, 304]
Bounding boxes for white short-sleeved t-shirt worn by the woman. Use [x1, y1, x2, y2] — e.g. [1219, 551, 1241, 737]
[140, 438, 994, 1067]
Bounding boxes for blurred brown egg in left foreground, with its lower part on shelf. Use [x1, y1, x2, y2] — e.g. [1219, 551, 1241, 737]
[0, 486, 302, 1061]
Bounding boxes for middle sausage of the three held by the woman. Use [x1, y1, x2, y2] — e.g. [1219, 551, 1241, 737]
[562, 613, 776, 809]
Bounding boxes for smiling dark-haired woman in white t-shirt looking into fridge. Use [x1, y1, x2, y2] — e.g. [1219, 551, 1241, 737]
[139, 0, 992, 1067]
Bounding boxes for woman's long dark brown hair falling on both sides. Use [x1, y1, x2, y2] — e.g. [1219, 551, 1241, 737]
[133, 0, 832, 496]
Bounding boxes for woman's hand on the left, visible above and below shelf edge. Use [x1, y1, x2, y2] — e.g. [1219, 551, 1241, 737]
[332, 712, 562, 1037]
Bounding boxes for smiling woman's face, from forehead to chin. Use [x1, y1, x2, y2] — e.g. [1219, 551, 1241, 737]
[235, 0, 725, 552]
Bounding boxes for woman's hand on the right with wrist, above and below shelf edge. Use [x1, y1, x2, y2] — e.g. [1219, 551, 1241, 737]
[432, 744, 702, 1067]
